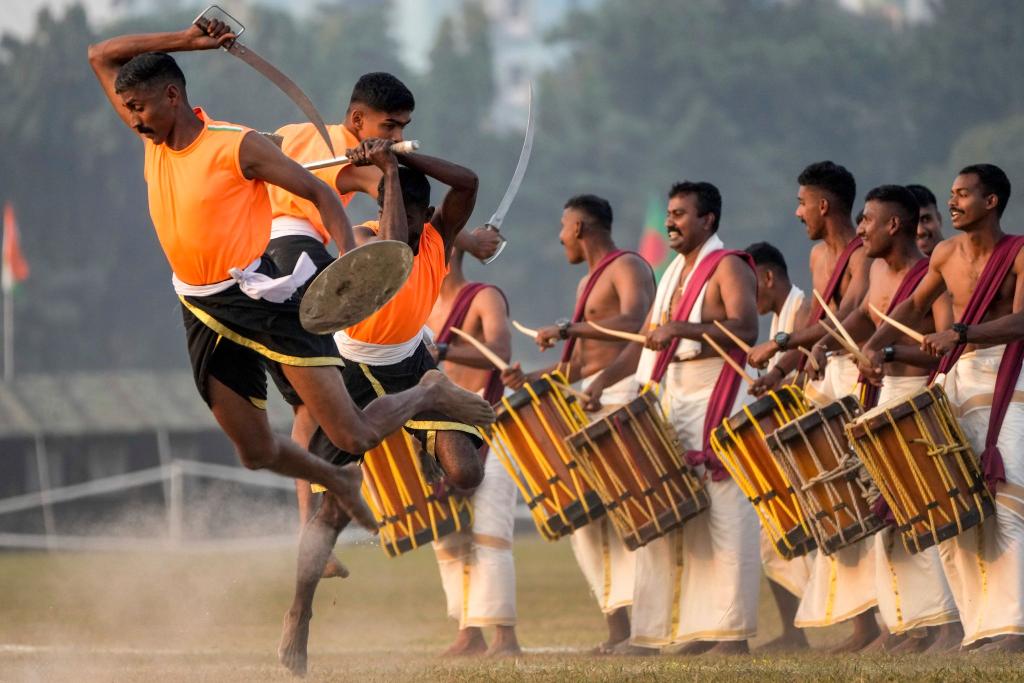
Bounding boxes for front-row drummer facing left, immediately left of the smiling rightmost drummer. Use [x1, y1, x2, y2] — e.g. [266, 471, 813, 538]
[812, 185, 964, 652]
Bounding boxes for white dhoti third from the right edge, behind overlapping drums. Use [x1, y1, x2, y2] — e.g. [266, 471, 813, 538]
[794, 355, 878, 629]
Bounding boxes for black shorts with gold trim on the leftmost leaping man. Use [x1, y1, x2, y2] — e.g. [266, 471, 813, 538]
[178, 257, 344, 408]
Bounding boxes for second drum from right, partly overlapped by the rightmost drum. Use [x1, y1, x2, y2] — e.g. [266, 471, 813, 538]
[767, 396, 883, 555]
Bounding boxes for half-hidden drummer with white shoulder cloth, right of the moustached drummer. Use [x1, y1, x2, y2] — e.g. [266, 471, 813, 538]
[744, 242, 814, 651]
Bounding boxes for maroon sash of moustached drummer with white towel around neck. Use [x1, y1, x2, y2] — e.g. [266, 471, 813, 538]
[651, 249, 754, 481]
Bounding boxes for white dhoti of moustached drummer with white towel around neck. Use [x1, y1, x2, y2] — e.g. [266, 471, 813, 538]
[630, 358, 761, 647]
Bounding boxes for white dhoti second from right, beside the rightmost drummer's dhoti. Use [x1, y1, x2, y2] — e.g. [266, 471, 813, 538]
[874, 377, 959, 634]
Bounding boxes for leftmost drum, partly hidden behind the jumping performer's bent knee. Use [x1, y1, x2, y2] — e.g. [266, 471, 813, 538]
[362, 429, 473, 557]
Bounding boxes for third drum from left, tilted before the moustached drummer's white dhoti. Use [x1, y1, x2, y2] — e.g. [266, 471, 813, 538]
[566, 392, 710, 550]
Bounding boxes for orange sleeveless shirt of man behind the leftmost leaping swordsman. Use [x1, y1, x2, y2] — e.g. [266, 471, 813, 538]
[267, 123, 359, 244]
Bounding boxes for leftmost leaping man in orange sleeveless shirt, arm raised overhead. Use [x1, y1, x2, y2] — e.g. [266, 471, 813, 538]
[89, 22, 494, 672]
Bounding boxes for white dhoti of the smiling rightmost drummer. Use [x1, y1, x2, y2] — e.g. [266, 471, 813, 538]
[939, 346, 1024, 645]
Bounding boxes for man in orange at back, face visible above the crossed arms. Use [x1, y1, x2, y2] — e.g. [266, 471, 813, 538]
[266, 72, 501, 578]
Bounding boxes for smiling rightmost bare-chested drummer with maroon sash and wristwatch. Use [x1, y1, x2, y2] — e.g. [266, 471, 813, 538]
[863, 164, 1024, 652]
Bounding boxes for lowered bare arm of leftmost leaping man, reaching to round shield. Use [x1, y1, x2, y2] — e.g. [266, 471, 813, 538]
[239, 131, 355, 254]
